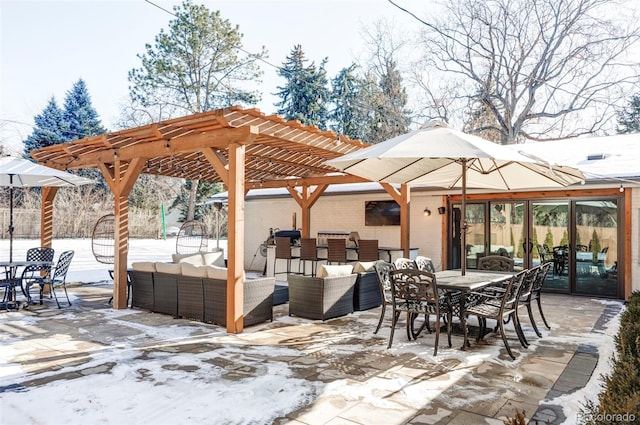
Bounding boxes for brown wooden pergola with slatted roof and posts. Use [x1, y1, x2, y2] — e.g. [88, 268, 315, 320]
[31, 106, 410, 333]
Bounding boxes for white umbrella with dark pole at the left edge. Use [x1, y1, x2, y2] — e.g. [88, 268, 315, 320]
[0, 156, 94, 262]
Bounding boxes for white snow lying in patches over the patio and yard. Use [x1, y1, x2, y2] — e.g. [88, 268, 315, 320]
[0, 239, 620, 425]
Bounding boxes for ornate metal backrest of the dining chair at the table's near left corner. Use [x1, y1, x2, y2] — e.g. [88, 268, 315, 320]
[389, 269, 439, 309]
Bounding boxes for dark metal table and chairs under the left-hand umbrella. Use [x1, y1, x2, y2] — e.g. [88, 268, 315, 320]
[0, 247, 74, 310]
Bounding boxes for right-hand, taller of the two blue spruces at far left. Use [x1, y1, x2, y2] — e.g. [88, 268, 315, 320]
[62, 79, 107, 141]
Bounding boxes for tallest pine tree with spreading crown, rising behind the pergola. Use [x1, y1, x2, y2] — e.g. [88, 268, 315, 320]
[129, 0, 267, 115]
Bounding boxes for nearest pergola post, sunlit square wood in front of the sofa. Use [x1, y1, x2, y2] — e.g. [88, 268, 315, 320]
[227, 143, 245, 334]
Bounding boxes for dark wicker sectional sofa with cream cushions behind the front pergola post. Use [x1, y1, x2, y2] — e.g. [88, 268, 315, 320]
[129, 252, 275, 326]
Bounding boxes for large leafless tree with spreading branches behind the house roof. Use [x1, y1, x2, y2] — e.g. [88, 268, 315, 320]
[389, 0, 640, 144]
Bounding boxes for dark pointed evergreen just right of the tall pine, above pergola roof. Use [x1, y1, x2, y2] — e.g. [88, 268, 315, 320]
[275, 45, 331, 130]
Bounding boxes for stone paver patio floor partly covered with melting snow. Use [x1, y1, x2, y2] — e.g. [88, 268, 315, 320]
[0, 282, 624, 425]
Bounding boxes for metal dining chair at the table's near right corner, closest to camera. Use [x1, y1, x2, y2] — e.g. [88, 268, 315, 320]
[463, 270, 527, 360]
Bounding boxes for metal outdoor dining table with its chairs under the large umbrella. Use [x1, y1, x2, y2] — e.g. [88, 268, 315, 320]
[375, 258, 551, 359]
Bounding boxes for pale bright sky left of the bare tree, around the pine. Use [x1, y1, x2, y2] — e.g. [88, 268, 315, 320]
[0, 0, 417, 153]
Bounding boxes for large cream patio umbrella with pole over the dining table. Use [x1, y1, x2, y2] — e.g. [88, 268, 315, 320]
[326, 122, 585, 275]
